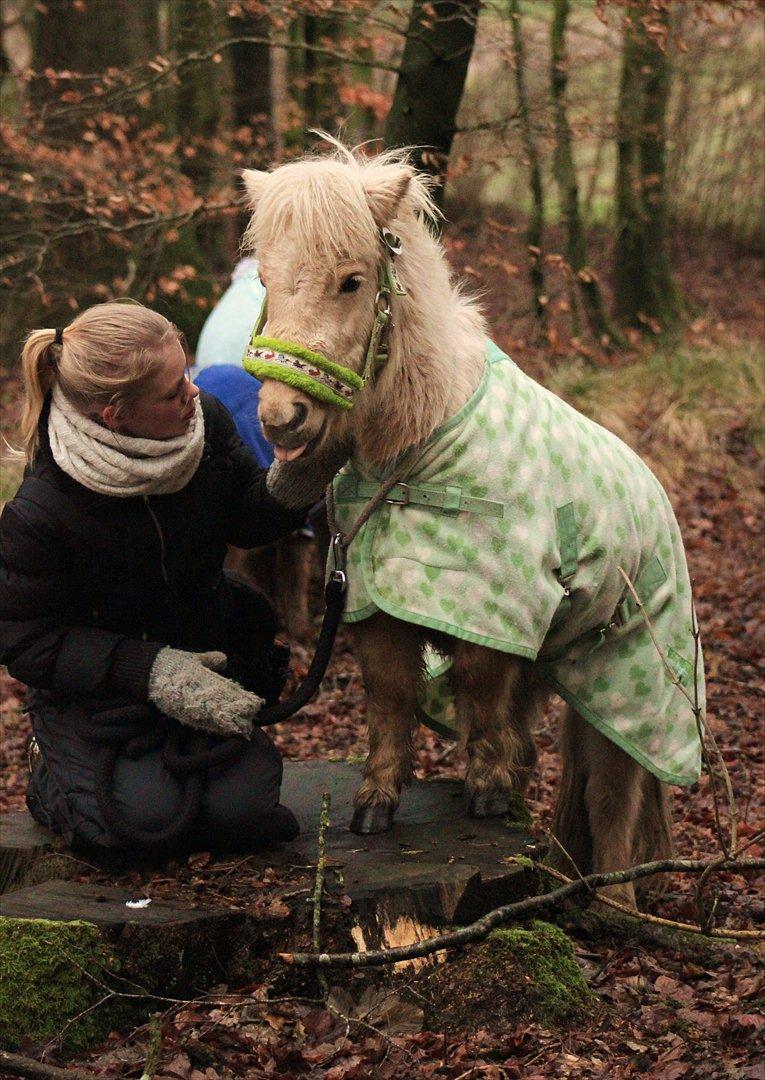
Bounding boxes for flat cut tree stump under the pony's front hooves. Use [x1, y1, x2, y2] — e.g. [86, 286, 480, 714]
[271, 761, 538, 948]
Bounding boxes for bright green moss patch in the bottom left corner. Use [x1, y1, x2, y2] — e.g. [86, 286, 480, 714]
[0, 918, 117, 1051]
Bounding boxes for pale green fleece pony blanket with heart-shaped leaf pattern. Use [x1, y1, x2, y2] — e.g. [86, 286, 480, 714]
[335, 343, 704, 784]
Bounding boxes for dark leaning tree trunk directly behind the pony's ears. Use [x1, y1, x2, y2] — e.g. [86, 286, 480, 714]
[385, 0, 481, 201]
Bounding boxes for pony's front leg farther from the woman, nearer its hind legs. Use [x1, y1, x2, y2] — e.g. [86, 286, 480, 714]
[453, 642, 537, 818]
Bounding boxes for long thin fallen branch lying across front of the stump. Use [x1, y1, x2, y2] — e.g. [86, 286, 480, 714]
[279, 859, 765, 968]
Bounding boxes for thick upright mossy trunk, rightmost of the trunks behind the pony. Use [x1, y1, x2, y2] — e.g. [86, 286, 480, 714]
[614, 0, 683, 332]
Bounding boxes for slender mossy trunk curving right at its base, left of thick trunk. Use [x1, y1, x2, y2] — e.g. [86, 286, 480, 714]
[550, 0, 618, 346]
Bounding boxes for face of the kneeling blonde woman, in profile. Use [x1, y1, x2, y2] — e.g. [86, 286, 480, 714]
[103, 340, 199, 438]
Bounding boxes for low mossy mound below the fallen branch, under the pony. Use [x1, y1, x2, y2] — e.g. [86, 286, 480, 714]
[424, 921, 596, 1031]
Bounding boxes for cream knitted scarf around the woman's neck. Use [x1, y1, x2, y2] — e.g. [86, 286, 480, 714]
[48, 387, 204, 499]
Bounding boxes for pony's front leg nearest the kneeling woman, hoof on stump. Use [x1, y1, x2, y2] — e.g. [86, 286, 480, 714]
[350, 611, 424, 834]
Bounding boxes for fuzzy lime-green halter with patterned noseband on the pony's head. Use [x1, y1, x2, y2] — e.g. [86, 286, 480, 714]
[243, 229, 406, 408]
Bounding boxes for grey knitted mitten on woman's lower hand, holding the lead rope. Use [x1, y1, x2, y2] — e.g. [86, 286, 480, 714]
[149, 648, 264, 739]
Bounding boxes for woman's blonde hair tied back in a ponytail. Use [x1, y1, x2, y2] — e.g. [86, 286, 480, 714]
[21, 301, 183, 461]
